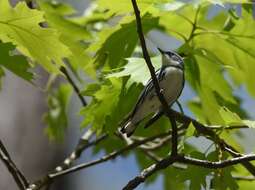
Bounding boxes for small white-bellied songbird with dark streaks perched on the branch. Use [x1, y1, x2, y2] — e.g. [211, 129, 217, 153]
[120, 48, 185, 137]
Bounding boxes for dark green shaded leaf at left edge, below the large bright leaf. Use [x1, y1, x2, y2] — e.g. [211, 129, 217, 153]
[0, 42, 33, 81]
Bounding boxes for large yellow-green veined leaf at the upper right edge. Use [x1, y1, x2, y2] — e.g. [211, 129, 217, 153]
[194, 6, 255, 96]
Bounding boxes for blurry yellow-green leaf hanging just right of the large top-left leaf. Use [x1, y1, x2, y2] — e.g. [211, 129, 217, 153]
[39, 2, 96, 78]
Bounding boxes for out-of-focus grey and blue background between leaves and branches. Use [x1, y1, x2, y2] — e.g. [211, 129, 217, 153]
[0, 0, 255, 190]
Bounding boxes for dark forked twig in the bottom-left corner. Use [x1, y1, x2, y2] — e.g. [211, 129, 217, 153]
[0, 140, 29, 190]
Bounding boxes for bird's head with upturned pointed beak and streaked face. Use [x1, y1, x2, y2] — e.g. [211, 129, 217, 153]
[158, 48, 184, 69]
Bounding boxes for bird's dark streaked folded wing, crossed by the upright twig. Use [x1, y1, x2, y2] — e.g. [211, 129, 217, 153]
[130, 69, 164, 117]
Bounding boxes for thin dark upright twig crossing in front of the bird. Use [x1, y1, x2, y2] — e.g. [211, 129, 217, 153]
[131, 0, 178, 155]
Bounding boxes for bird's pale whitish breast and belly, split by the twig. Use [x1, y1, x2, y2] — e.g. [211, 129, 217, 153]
[132, 67, 184, 123]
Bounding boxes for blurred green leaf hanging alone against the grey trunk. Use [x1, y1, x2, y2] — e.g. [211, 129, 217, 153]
[44, 84, 72, 141]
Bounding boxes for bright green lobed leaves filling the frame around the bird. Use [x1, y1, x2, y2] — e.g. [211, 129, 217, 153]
[0, 0, 255, 190]
